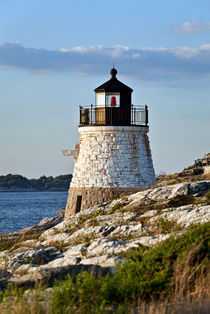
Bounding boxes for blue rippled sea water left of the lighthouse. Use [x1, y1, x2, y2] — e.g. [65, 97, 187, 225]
[0, 192, 68, 234]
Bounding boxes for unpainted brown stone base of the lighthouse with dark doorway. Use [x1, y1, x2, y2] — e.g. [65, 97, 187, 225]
[65, 187, 144, 219]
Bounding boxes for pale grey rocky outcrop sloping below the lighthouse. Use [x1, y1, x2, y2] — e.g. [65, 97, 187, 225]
[0, 181, 210, 289]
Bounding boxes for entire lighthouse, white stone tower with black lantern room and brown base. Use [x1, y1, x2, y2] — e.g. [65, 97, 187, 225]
[63, 68, 156, 218]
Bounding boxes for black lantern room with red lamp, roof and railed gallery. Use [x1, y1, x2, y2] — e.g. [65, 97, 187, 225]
[80, 68, 148, 126]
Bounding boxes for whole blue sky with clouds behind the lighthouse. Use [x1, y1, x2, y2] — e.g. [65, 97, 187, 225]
[0, 0, 210, 178]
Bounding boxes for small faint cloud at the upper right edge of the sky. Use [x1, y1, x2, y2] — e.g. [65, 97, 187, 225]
[174, 20, 210, 33]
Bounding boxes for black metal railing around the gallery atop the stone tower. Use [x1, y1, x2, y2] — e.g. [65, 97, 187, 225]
[80, 105, 148, 126]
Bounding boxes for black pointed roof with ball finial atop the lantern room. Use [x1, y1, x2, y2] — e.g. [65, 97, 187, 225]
[94, 68, 133, 93]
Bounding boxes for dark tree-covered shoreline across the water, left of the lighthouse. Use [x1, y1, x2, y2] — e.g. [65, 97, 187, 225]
[0, 174, 72, 191]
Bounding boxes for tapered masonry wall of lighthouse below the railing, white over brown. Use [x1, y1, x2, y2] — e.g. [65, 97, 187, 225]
[66, 126, 156, 216]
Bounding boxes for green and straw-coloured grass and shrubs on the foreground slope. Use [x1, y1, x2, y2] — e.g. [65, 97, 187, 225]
[0, 223, 210, 314]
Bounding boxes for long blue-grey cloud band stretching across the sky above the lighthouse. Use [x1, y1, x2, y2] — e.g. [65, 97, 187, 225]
[0, 43, 210, 79]
